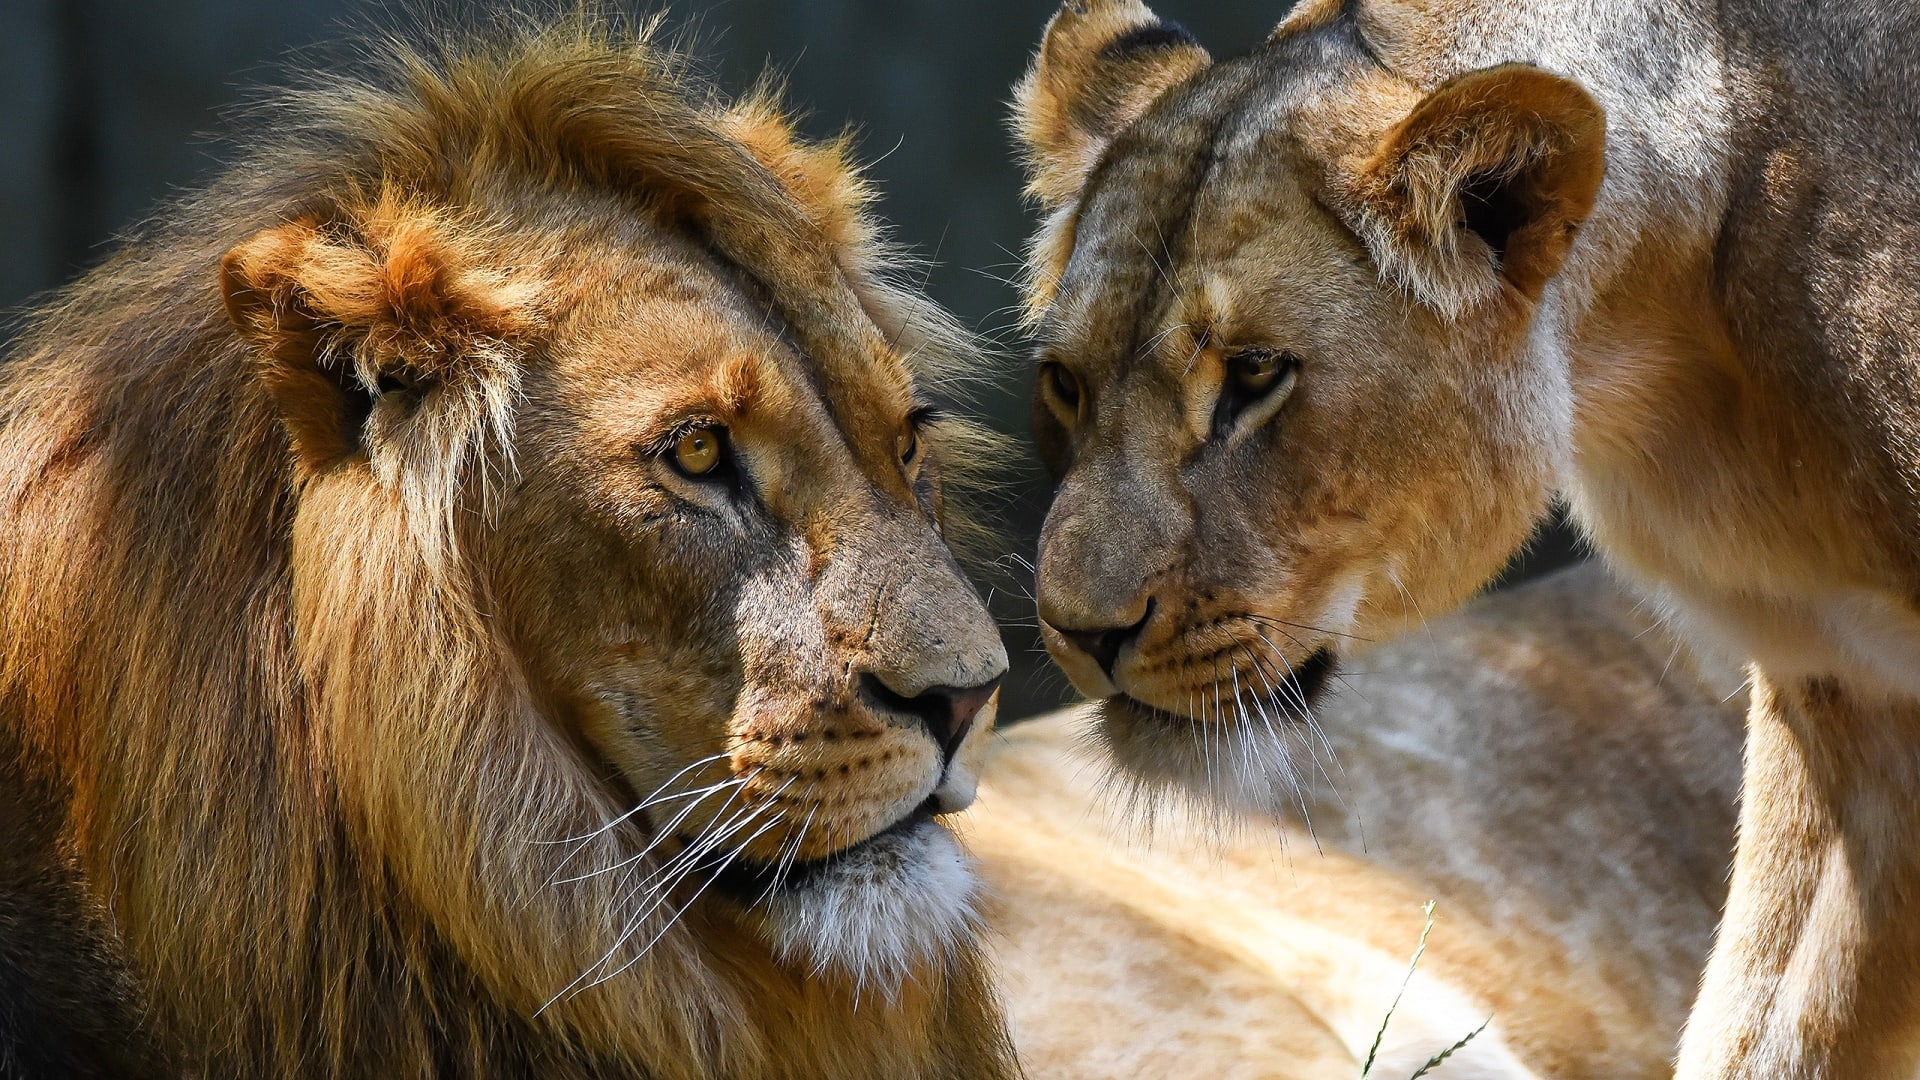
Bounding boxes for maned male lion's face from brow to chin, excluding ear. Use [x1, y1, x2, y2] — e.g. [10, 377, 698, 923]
[492, 214, 1006, 976]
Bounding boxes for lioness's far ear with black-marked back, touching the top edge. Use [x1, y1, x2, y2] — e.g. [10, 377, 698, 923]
[1014, 0, 1212, 209]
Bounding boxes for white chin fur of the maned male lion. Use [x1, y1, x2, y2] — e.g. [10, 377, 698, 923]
[756, 821, 979, 992]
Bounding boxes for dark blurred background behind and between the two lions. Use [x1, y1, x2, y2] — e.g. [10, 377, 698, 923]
[0, 0, 1569, 717]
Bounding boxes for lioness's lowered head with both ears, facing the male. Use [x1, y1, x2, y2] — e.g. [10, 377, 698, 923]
[1021, 2, 1597, 798]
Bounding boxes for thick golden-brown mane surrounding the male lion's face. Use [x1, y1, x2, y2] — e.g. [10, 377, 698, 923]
[0, 17, 1012, 1078]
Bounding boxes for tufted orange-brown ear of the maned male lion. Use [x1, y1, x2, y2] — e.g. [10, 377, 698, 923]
[221, 200, 538, 469]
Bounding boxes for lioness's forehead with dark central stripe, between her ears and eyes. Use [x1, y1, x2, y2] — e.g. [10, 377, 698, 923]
[1039, 40, 1373, 380]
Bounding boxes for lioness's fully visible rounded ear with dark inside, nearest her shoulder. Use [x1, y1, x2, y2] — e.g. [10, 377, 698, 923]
[1350, 63, 1607, 317]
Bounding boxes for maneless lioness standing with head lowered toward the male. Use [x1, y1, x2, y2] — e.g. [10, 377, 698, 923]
[1020, 0, 1920, 1078]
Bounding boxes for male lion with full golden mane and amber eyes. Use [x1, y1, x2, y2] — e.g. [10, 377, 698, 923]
[0, 21, 1016, 1080]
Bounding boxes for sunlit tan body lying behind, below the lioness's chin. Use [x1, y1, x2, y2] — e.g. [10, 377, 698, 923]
[964, 567, 1743, 1080]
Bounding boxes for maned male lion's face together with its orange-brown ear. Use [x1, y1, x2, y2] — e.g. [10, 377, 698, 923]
[227, 168, 1006, 980]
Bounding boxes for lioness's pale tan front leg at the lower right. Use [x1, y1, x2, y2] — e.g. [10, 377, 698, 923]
[1678, 673, 1920, 1080]
